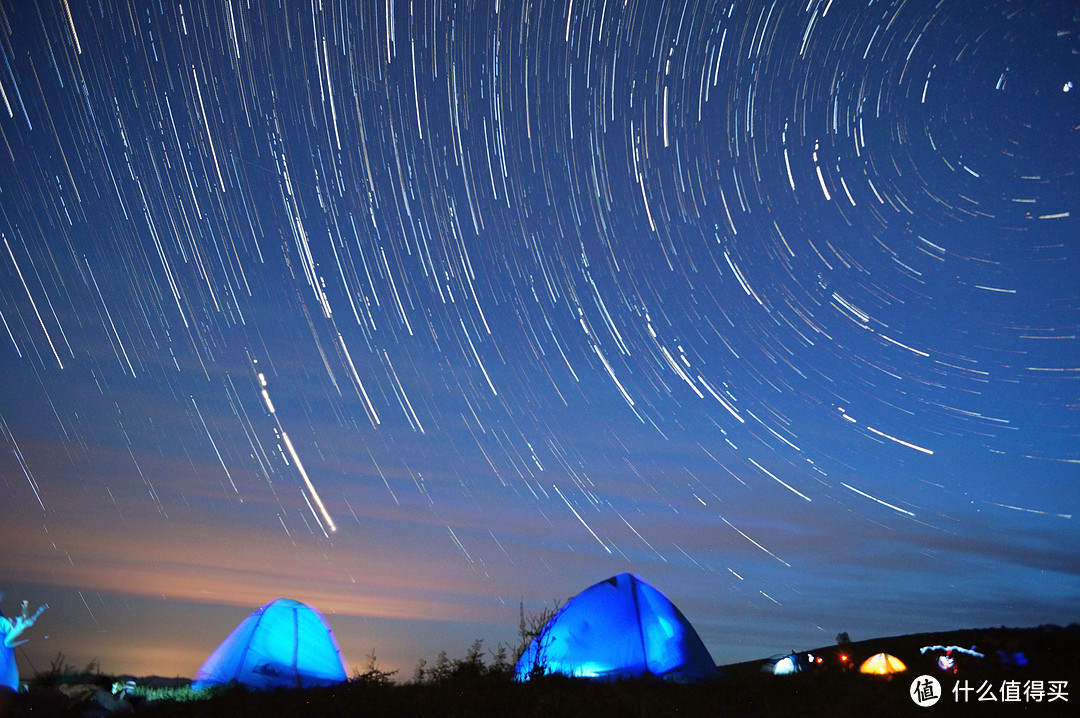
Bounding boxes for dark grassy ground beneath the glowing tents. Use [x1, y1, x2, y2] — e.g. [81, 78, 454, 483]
[0, 624, 1080, 718]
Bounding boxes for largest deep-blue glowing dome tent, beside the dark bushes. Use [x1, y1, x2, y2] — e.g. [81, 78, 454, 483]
[514, 573, 718, 681]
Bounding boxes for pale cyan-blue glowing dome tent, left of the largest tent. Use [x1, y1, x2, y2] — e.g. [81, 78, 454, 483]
[191, 598, 346, 690]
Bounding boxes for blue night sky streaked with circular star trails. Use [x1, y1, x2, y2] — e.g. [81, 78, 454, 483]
[0, 0, 1080, 678]
